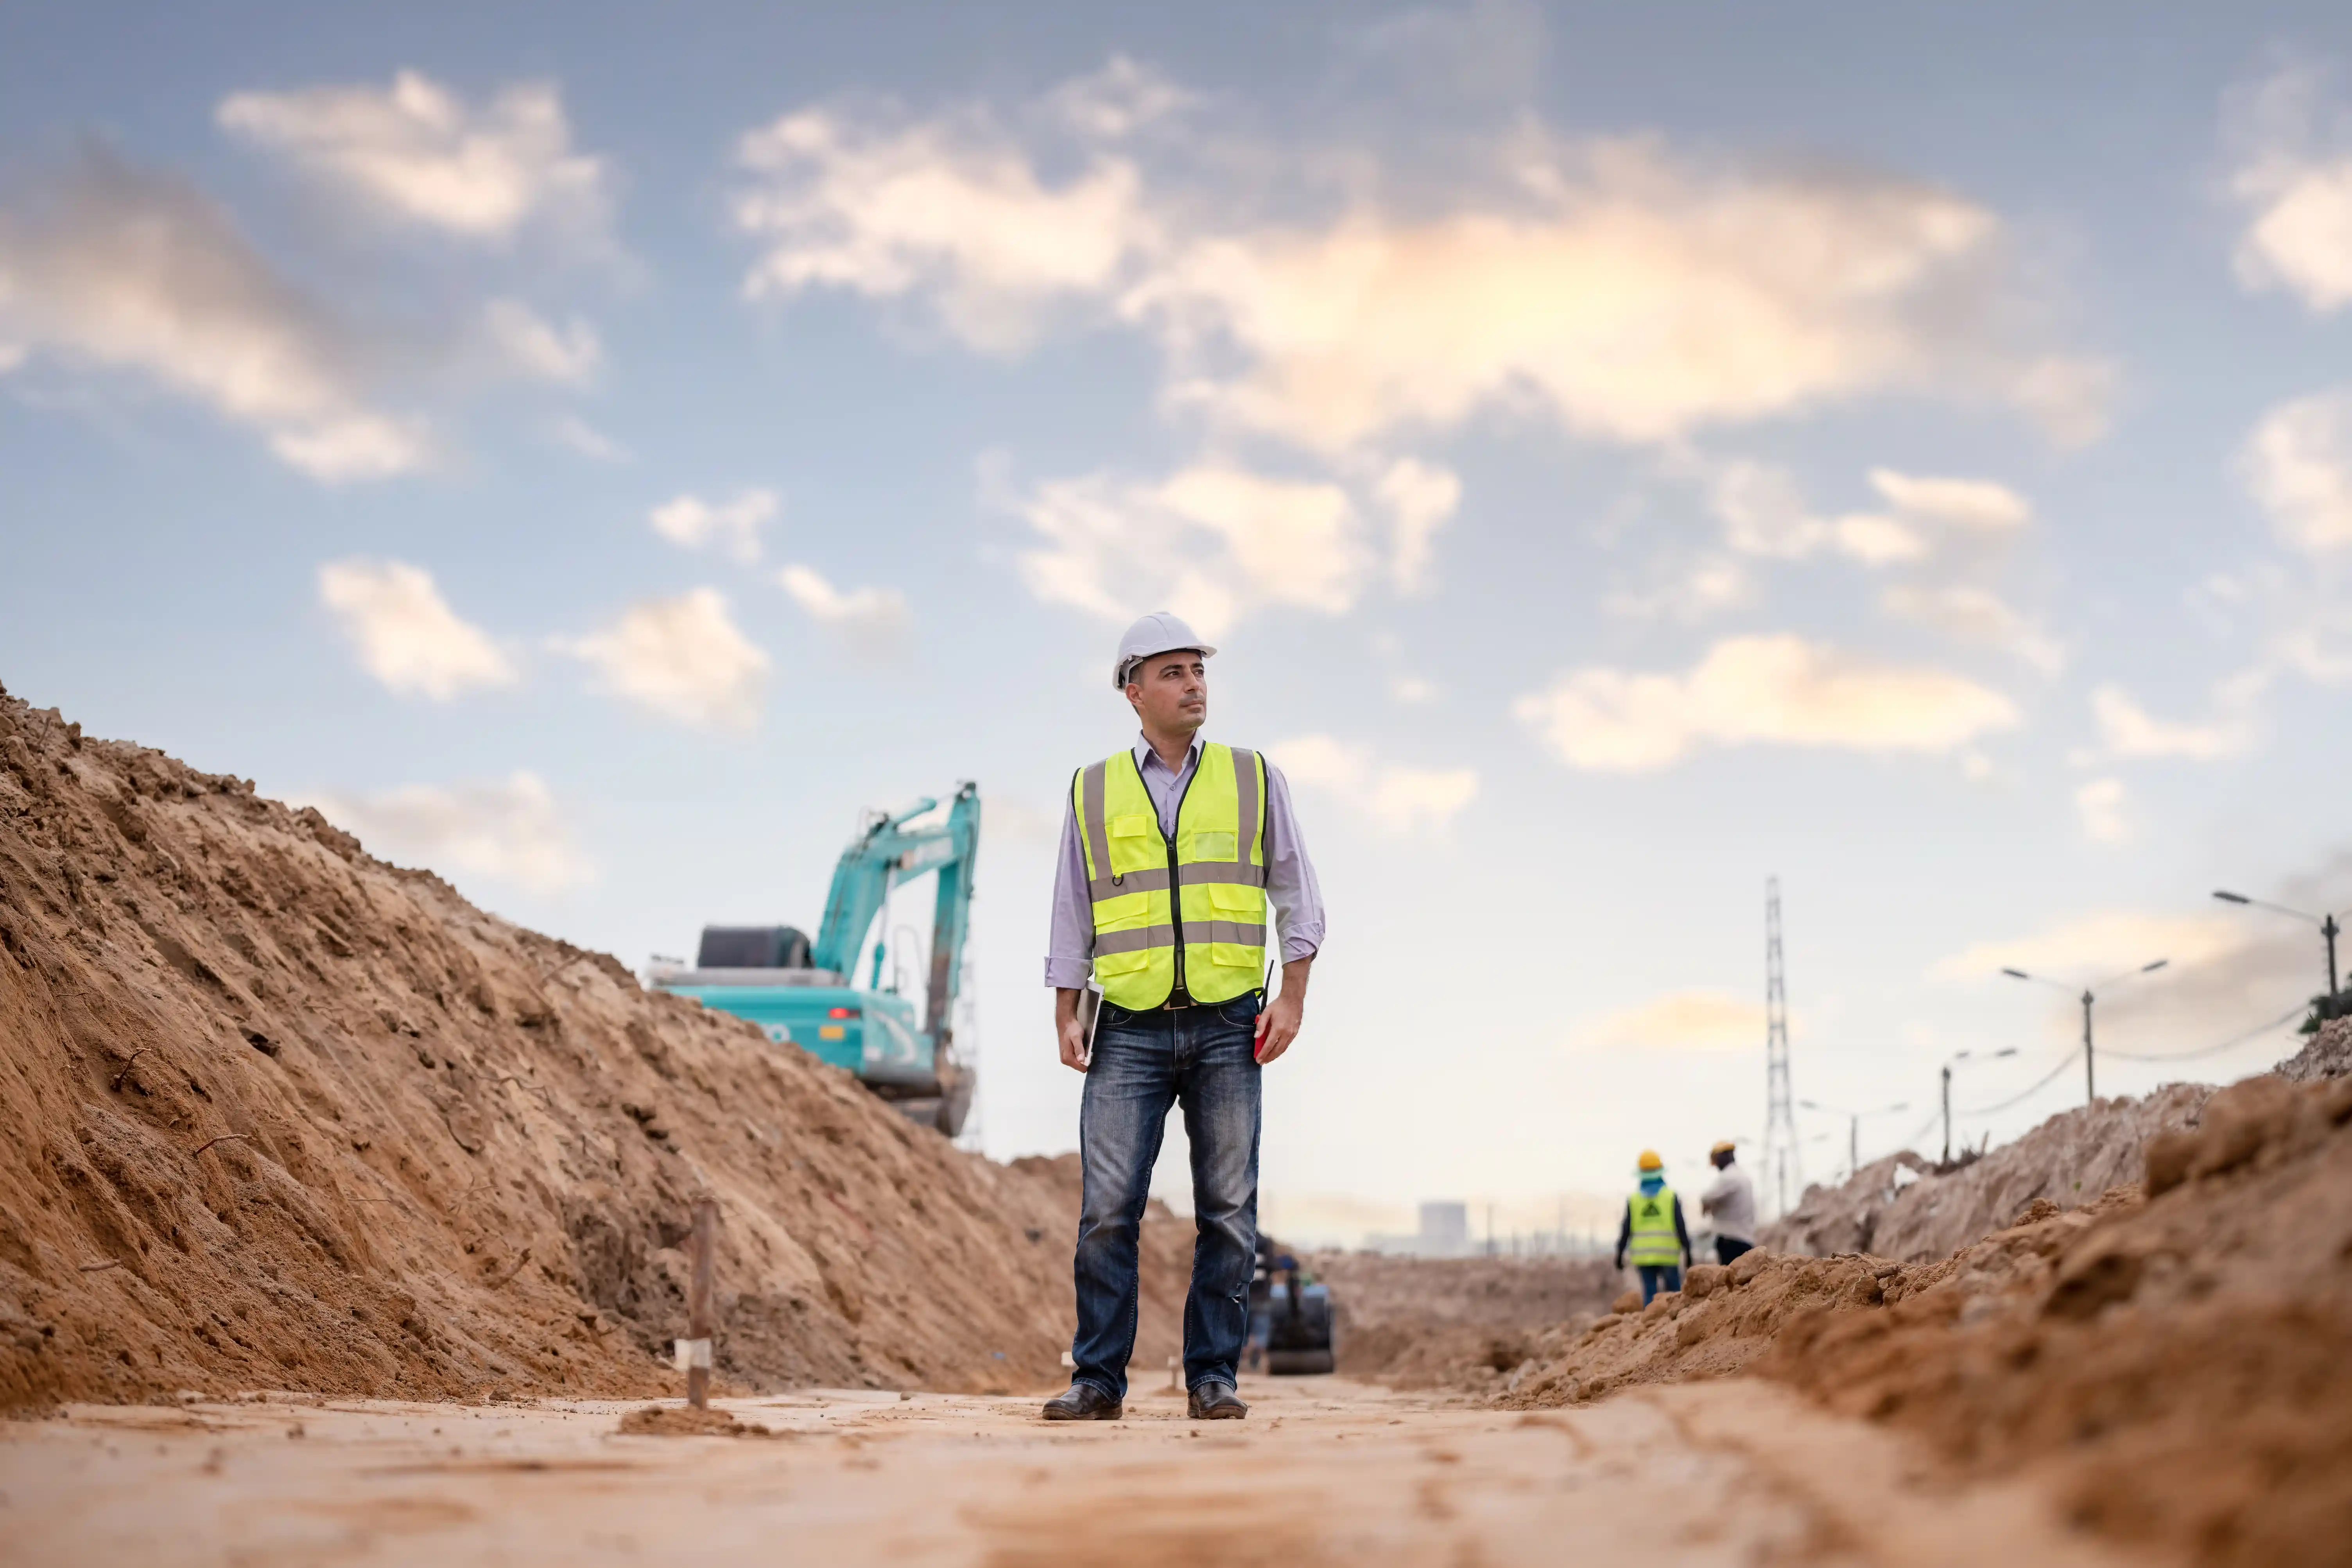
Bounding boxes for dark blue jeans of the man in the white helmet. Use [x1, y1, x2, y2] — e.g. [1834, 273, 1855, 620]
[1070, 995, 1258, 1399]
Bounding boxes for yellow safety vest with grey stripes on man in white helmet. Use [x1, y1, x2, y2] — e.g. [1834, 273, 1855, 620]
[1070, 743, 1266, 1011]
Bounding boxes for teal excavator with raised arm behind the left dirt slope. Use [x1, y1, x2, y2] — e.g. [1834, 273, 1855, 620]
[651, 783, 981, 1138]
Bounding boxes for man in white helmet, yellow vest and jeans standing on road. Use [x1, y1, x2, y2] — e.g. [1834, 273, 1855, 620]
[1044, 614, 1324, 1420]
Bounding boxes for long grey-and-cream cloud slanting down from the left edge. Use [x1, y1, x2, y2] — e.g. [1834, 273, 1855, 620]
[0, 153, 433, 482]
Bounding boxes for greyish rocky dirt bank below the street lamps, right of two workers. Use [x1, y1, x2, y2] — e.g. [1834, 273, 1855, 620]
[1759, 1084, 2213, 1262]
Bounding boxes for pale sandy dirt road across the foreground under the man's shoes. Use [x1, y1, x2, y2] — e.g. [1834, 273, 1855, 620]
[0, 1378, 2148, 1568]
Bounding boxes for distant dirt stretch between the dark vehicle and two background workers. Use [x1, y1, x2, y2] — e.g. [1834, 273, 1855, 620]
[1305, 1253, 1621, 1387]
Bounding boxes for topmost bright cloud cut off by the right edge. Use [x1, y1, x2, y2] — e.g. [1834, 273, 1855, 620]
[2230, 66, 2352, 315]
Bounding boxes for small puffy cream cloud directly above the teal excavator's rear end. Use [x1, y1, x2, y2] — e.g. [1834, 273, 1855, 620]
[555, 588, 769, 729]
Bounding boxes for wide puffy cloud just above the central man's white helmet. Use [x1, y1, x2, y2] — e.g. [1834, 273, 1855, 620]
[1011, 461, 1373, 637]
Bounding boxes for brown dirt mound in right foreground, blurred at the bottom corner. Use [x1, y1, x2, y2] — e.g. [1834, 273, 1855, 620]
[1503, 1077, 2352, 1566]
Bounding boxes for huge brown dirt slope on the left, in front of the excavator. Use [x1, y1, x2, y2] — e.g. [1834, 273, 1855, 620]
[0, 694, 1183, 1406]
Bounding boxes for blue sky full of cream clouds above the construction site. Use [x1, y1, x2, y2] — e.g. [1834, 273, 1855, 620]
[0, 5, 2352, 1227]
